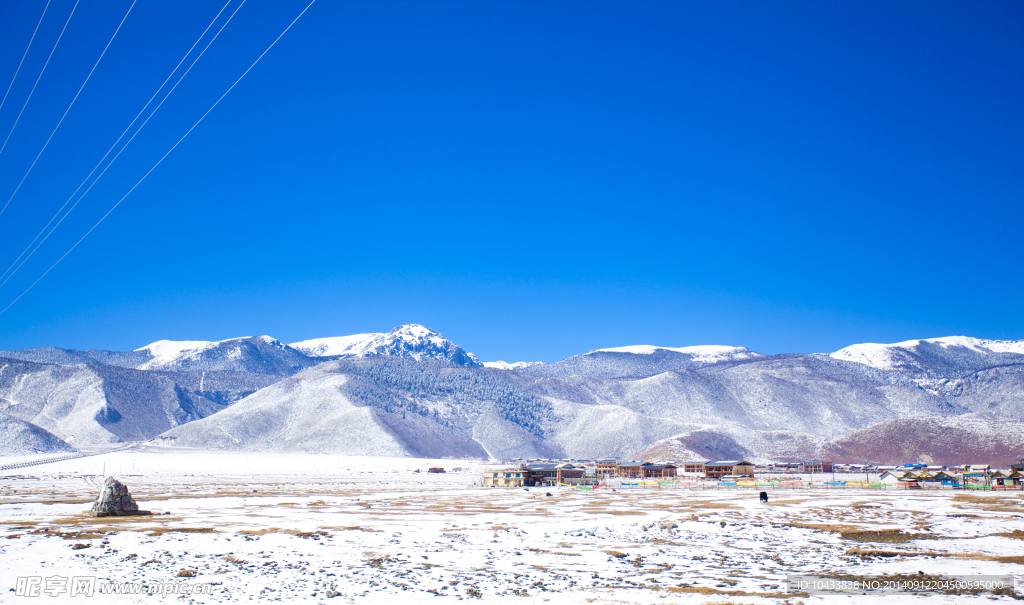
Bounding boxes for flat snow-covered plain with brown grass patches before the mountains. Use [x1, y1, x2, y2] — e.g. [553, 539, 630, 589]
[0, 448, 1024, 604]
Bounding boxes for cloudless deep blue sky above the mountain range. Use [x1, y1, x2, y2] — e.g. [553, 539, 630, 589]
[0, 0, 1024, 361]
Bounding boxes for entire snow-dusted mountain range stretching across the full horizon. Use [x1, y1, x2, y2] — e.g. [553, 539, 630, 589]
[0, 325, 1024, 464]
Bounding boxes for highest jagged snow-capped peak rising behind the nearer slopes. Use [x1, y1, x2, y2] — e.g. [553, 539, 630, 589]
[291, 323, 483, 368]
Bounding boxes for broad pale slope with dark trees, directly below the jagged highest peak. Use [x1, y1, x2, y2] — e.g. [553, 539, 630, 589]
[157, 357, 557, 458]
